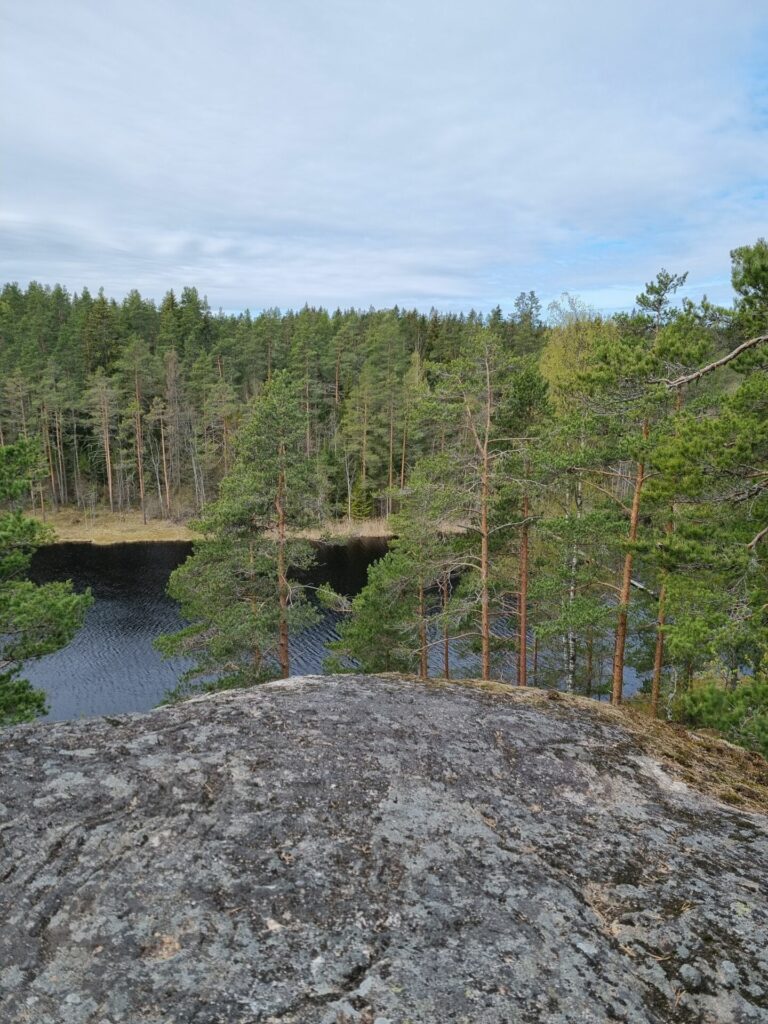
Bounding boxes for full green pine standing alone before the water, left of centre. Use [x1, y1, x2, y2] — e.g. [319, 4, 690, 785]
[157, 371, 319, 699]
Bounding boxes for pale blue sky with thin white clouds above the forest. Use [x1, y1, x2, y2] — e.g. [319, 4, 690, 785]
[0, 0, 768, 311]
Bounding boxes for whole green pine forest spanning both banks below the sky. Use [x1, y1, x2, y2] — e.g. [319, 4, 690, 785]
[0, 239, 768, 753]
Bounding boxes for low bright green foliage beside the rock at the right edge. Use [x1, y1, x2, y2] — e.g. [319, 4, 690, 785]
[679, 679, 768, 758]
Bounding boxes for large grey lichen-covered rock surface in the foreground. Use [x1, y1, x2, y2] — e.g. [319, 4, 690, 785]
[0, 677, 768, 1024]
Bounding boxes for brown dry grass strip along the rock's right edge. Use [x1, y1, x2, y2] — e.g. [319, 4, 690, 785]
[387, 677, 768, 814]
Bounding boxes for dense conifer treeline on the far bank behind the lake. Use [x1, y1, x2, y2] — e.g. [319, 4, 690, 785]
[0, 284, 545, 517]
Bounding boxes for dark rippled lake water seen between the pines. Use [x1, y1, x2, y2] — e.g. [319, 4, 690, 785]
[25, 539, 386, 721]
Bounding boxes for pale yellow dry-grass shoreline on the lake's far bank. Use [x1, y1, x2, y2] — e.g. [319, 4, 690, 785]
[27, 509, 392, 545]
